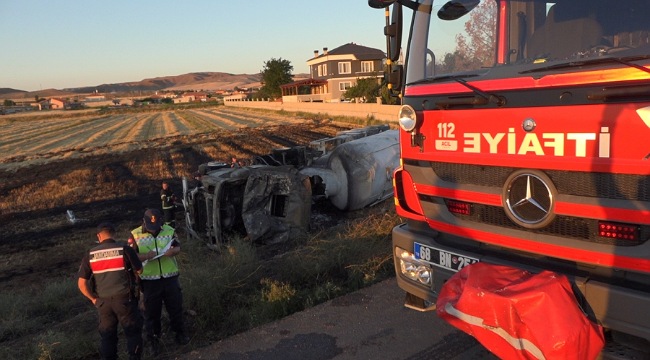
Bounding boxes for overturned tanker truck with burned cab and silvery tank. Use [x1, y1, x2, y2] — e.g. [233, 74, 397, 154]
[183, 125, 399, 248]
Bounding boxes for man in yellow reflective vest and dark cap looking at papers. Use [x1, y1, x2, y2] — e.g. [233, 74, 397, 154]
[129, 209, 189, 355]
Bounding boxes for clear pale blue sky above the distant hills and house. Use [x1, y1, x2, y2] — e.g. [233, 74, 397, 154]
[0, 0, 385, 91]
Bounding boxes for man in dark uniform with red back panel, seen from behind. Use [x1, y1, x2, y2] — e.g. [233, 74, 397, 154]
[77, 222, 143, 359]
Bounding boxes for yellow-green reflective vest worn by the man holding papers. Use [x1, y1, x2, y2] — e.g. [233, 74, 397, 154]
[131, 225, 178, 280]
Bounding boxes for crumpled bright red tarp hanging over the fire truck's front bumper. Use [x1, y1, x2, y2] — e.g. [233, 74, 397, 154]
[436, 263, 605, 359]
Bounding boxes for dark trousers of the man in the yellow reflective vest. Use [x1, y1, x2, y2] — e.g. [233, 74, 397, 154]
[141, 276, 184, 340]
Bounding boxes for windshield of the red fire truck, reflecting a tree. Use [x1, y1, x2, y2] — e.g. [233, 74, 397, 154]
[405, 0, 650, 85]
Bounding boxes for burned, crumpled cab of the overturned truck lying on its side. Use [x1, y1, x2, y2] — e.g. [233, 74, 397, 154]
[183, 165, 311, 245]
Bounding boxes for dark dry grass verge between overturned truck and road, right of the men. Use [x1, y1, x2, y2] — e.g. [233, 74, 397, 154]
[181, 204, 400, 343]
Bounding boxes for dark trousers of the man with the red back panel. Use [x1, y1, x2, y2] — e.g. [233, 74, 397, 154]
[95, 296, 142, 360]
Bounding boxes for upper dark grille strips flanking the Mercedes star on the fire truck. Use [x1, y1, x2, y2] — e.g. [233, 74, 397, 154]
[431, 162, 650, 201]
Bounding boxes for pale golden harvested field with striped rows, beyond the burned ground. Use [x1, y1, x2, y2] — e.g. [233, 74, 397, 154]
[0, 107, 305, 170]
